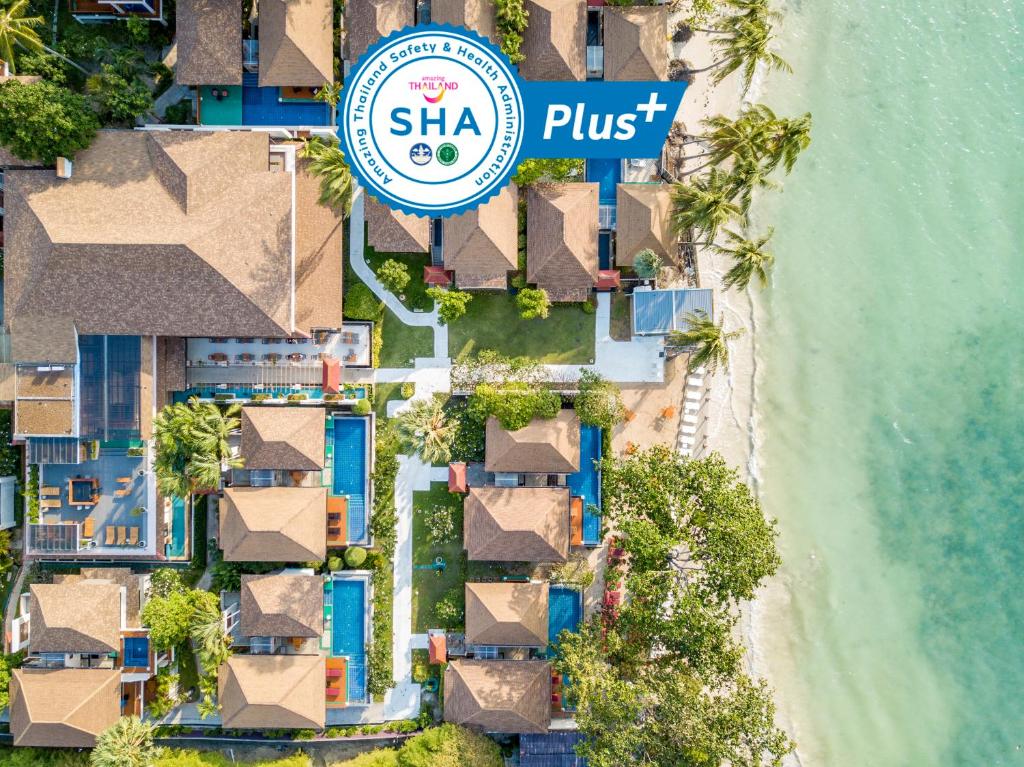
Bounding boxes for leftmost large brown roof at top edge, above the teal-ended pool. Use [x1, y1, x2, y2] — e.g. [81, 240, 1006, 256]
[174, 0, 242, 85]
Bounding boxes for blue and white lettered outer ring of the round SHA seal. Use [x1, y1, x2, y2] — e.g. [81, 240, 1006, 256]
[338, 24, 526, 217]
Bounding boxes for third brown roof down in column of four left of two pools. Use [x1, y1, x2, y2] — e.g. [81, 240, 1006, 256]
[240, 573, 324, 637]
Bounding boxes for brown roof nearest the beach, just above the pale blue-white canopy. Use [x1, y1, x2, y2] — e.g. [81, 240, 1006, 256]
[615, 183, 677, 266]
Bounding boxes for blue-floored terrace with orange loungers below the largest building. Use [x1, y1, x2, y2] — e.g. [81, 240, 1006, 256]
[28, 451, 156, 557]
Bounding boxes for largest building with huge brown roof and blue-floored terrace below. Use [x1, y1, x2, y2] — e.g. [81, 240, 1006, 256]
[4, 131, 341, 561]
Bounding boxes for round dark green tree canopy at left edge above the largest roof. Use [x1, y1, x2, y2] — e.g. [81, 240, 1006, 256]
[0, 80, 99, 165]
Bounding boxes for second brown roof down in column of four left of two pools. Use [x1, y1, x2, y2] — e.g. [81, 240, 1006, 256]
[220, 487, 327, 562]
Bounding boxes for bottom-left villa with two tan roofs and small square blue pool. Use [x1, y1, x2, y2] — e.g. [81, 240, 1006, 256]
[10, 568, 164, 748]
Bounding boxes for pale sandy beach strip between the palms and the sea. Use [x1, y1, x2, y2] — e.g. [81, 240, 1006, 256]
[677, 20, 803, 767]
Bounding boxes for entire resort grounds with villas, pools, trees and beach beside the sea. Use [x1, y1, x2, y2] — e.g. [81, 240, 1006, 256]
[0, 0, 810, 767]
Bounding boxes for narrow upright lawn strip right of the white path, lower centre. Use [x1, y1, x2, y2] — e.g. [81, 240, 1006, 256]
[413, 482, 466, 634]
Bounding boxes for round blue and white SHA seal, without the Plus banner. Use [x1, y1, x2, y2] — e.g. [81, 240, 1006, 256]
[339, 25, 524, 216]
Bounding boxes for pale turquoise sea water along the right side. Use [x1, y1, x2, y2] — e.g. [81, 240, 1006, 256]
[755, 0, 1024, 767]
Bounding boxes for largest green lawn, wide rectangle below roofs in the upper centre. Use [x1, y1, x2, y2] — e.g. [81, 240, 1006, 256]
[449, 293, 595, 365]
